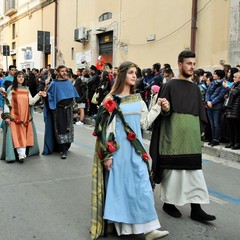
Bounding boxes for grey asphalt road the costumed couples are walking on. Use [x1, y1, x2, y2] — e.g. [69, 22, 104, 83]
[0, 113, 240, 240]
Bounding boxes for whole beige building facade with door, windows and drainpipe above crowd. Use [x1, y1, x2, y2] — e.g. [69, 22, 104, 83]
[0, 0, 240, 70]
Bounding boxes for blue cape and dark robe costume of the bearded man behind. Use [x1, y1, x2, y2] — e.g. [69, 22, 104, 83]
[43, 80, 79, 158]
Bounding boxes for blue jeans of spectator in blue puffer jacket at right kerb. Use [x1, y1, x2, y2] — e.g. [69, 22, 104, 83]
[207, 109, 222, 141]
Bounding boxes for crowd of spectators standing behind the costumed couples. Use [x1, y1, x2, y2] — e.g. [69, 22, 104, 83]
[0, 61, 240, 150]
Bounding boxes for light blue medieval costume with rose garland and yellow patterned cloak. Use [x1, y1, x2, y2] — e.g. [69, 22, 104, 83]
[90, 94, 168, 239]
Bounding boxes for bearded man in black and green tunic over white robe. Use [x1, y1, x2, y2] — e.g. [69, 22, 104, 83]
[150, 51, 216, 222]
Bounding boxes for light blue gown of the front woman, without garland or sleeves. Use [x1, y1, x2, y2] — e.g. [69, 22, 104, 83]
[104, 95, 158, 224]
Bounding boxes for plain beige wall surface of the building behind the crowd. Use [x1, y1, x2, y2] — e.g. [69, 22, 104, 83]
[0, 0, 239, 70]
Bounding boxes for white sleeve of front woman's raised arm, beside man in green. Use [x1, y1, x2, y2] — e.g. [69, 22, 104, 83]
[141, 100, 161, 130]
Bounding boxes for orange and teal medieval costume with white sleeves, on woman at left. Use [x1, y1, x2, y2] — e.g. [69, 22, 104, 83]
[1, 86, 40, 162]
